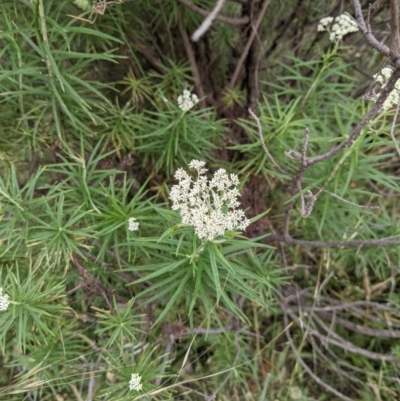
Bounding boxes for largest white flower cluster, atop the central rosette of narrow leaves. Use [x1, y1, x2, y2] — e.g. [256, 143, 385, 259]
[170, 160, 250, 242]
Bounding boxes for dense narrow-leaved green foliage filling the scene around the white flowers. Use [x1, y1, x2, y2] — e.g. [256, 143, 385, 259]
[0, 0, 400, 401]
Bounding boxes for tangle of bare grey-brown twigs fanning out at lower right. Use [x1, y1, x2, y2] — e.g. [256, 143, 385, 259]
[278, 287, 400, 396]
